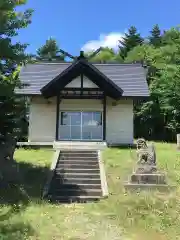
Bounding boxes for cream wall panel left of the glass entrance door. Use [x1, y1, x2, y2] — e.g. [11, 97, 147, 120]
[28, 97, 56, 142]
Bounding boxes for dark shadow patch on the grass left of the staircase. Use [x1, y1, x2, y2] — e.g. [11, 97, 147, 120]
[0, 158, 49, 206]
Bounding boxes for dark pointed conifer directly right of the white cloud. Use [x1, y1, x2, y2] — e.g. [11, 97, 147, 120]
[119, 26, 144, 59]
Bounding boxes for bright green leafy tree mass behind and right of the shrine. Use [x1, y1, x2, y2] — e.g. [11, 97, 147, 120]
[125, 28, 180, 140]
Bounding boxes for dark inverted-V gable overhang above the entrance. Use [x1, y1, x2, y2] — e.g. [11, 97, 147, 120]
[40, 59, 123, 99]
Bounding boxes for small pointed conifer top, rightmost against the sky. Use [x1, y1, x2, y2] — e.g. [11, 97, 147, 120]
[149, 24, 162, 47]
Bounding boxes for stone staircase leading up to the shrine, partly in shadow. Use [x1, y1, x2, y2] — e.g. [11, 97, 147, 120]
[47, 149, 102, 202]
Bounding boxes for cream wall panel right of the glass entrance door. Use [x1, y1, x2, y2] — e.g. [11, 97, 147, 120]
[106, 99, 134, 144]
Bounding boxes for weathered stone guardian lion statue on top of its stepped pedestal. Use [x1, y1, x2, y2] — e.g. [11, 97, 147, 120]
[137, 138, 156, 173]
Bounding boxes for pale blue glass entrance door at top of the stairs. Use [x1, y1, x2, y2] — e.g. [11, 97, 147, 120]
[59, 111, 103, 141]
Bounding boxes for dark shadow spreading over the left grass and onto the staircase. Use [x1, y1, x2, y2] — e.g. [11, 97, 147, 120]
[0, 157, 92, 207]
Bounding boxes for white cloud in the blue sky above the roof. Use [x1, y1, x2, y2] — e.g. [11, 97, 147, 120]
[82, 32, 124, 52]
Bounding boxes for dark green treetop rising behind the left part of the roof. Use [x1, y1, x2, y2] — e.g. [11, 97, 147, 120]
[37, 38, 65, 61]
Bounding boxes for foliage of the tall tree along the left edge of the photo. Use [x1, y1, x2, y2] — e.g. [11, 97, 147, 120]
[0, 0, 33, 141]
